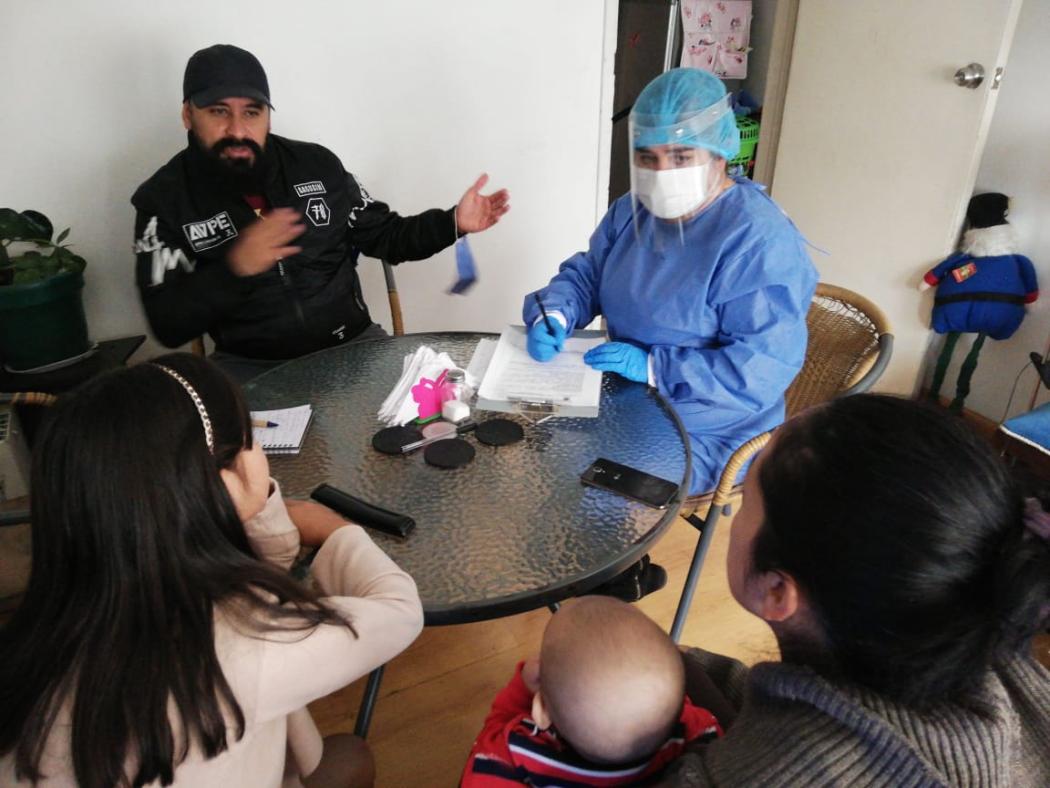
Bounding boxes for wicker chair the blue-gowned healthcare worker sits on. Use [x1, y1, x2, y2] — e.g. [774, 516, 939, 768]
[671, 284, 894, 642]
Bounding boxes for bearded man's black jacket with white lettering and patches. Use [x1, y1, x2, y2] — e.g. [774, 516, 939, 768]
[131, 134, 456, 358]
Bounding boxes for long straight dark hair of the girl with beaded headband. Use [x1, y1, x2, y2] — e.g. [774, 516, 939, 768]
[0, 353, 344, 788]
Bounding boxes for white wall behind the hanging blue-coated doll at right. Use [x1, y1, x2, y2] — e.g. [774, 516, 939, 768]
[936, 0, 1050, 421]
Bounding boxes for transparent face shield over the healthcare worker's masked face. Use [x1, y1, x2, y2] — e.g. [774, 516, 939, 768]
[628, 96, 732, 247]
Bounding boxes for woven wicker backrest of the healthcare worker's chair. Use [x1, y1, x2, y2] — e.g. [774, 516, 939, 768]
[784, 283, 894, 418]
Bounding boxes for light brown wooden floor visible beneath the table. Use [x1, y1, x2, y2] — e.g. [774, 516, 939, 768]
[310, 508, 777, 788]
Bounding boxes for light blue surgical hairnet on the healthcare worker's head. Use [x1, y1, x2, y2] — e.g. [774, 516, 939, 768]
[631, 68, 740, 159]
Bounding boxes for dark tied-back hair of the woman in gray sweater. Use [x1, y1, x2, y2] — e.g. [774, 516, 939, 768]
[752, 395, 1050, 707]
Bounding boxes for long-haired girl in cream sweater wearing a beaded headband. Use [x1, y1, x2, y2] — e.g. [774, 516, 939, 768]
[0, 353, 423, 788]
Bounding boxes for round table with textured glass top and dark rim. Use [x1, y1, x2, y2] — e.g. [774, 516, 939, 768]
[245, 333, 690, 624]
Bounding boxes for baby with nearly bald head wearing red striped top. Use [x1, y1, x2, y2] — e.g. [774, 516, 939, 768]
[461, 597, 721, 788]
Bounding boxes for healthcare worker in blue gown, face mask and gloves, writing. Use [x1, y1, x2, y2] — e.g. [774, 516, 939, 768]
[523, 68, 817, 494]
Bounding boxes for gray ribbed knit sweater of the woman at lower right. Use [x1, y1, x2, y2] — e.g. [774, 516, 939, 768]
[660, 649, 1050, 788]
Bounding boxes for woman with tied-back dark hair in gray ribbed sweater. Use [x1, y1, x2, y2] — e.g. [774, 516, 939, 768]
[664, 395, 1050, 787]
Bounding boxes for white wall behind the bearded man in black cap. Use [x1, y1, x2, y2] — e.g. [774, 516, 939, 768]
[0, 0, 616, 363]
